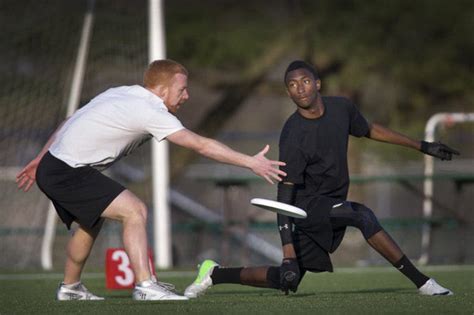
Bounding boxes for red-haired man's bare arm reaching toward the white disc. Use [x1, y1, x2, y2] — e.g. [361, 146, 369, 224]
[167, 129, 286, 184]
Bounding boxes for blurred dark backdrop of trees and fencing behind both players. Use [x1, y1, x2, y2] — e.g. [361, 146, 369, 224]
[0, 0, 474, 270]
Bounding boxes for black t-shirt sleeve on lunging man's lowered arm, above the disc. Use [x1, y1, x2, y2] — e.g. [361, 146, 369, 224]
[279, 125, 307, 184]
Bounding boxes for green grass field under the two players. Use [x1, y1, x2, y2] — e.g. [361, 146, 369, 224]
[0, 266, 474, 315]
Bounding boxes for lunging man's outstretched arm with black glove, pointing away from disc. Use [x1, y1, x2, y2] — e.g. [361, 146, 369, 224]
[367, 123, 459, 160]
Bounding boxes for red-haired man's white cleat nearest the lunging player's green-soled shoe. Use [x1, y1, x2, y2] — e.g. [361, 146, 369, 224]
[132, 280, 188, 301]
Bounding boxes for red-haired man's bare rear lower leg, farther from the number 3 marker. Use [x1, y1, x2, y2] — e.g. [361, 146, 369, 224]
[63, 220, 103, 285]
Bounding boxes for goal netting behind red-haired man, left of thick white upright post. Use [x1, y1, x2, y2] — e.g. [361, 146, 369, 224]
[0, 0, 151, 269]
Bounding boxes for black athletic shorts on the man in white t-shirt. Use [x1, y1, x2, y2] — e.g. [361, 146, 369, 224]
[36, 152, 125, 229]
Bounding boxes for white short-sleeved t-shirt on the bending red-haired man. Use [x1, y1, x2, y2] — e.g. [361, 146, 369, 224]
[49, 85, 184, 169]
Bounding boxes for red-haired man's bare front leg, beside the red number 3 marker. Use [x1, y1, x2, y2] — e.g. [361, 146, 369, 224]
[102, 190, 151, 283]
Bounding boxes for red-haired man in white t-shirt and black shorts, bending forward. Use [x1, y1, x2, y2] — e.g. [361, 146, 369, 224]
[17, 60, 286, 300]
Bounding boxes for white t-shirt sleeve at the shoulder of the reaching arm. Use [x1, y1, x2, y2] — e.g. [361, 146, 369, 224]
[145, 109, 184, 141]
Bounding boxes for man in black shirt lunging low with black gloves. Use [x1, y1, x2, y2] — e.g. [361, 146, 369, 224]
[185, 61, 459, 297]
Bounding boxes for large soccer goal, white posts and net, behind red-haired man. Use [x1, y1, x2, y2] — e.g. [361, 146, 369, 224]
[0, 0, 172, 269]
